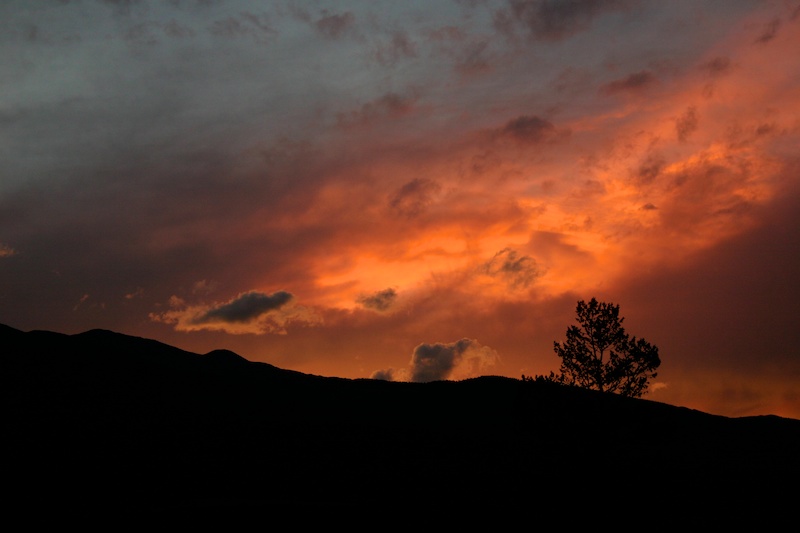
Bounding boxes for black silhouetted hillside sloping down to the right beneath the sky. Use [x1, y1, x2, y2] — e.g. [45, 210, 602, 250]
[0, 325, 800, 529]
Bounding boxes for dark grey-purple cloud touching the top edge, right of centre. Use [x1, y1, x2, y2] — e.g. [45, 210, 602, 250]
[494, 0, 634, 41]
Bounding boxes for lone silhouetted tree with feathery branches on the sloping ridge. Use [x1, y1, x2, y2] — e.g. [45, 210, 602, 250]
[523, 298, 661, 398]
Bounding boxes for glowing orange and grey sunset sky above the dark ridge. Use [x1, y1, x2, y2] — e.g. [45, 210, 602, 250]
[0, 0, 800, 419]
